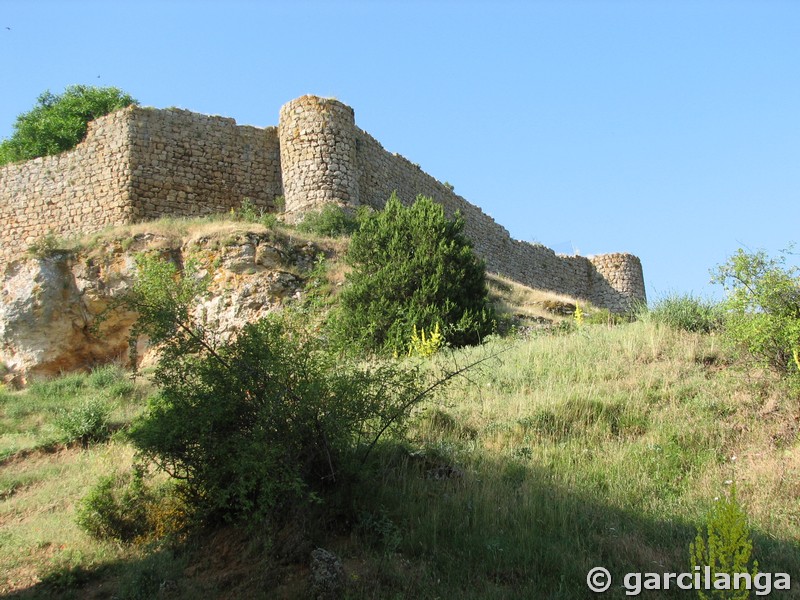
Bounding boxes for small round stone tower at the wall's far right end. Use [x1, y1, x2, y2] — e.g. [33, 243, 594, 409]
[589, 253, 647, 313]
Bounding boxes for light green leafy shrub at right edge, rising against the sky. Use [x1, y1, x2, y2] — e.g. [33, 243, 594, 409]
[713, 249, 800, 373]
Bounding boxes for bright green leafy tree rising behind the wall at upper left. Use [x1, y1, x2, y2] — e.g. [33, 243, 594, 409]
[0, 85, 136, 165]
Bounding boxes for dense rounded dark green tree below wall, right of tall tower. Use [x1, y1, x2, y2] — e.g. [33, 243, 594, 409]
[334, 194, 495, 354]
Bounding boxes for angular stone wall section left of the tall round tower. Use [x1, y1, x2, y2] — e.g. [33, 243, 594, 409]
[0, 107, 283, 266]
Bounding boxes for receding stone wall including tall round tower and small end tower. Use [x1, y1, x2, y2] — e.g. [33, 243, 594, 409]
[279, 96, 645, 312]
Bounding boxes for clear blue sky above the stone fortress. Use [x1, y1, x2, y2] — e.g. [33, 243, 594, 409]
[0, 0, 800, 300]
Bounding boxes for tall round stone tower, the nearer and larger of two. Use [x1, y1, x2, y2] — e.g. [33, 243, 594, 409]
[278, 96, 358, 221]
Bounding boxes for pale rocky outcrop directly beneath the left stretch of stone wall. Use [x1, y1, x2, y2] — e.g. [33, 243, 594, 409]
[0, 225, 324, 384]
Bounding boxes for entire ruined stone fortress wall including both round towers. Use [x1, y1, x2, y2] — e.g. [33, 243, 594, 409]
[0, 96, 645, 311]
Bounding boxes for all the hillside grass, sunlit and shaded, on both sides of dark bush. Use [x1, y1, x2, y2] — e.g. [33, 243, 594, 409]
[0, 320, 800, 600]
